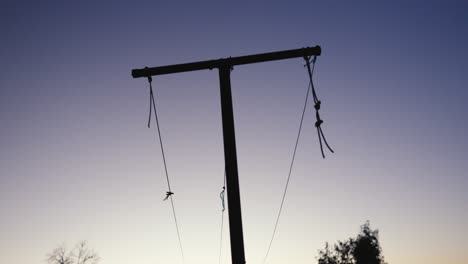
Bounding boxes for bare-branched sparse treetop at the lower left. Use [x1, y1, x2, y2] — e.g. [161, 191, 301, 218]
[47, 241, 99, 264]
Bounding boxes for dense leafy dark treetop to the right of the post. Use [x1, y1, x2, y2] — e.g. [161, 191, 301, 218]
[318, 221, 384, 264]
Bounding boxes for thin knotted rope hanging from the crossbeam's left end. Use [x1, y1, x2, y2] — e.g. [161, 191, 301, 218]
[148, 76, 185, 262]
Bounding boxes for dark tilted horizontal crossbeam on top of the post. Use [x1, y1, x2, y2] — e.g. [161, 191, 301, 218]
[132, 46, 322, 78]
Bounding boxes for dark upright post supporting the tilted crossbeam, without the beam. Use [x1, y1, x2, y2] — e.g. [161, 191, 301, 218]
[219, 67, 249, 264]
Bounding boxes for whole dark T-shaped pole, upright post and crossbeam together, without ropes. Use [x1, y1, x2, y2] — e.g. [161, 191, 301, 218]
[132, 46, 321, 264]
